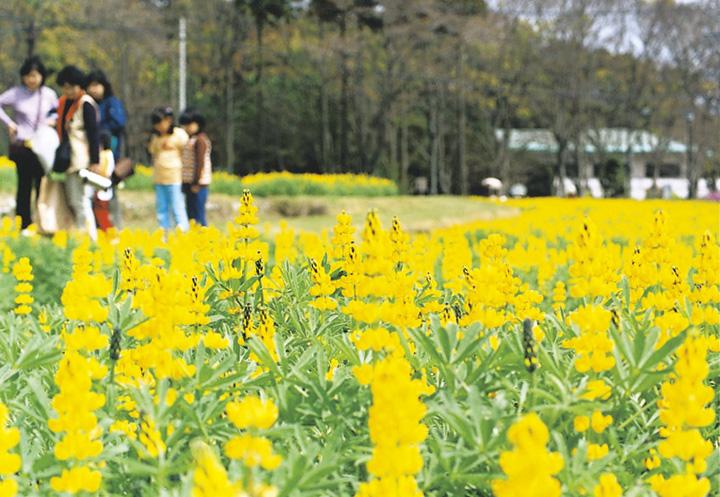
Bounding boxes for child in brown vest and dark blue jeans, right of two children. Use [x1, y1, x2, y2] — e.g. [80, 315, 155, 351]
[180, 110, 212, 226]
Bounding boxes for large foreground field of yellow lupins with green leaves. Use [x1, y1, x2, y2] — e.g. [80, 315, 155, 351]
[0, 196, 720, 497]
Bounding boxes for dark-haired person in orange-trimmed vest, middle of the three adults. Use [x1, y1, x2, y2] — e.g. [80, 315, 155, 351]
[57, 66, 100, 240]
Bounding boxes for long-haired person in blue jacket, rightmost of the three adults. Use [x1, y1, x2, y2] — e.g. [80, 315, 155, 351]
[85, 70, 127, 228]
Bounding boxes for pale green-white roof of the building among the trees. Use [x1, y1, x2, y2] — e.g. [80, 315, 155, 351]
[495, 128, 687, 154]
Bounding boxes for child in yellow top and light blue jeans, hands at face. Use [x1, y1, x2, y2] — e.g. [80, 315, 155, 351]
[148, 107, 190, 235]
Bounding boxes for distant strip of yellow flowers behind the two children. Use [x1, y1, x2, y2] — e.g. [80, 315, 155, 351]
[121, 166, 398, 197]
